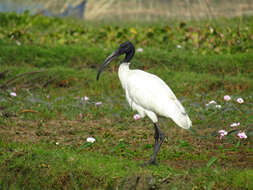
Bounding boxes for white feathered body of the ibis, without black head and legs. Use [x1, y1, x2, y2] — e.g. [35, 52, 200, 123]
[118, 63, 192, 129]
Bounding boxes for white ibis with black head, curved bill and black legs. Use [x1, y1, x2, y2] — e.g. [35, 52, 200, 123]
[97, 41, 192, 165]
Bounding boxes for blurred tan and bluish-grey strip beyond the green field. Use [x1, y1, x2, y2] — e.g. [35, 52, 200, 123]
[0, 0, 253, 21]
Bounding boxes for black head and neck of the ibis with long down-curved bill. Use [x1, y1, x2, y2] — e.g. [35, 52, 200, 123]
[97, 41, 135, 80]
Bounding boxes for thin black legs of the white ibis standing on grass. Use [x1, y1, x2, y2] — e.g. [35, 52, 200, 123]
[145, 123, 165, 165]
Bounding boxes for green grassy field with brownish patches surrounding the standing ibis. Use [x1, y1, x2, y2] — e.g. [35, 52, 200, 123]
[0, 13, 253, 190]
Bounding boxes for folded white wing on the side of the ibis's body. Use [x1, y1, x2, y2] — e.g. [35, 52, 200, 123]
[126, 70, 191, 128]
